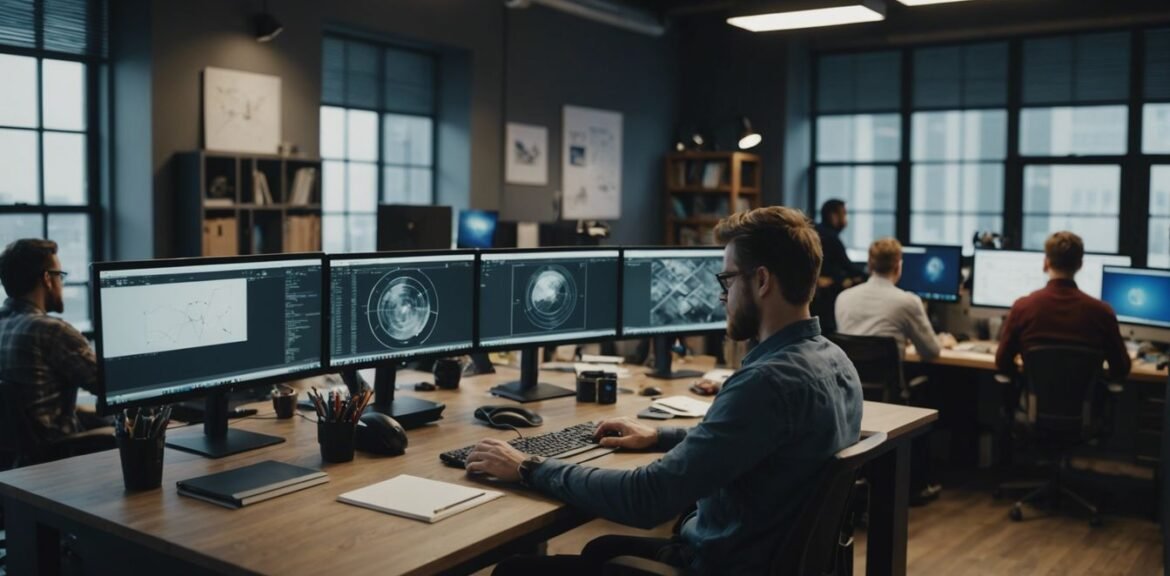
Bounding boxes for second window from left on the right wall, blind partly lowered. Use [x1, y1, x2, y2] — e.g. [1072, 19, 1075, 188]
[910, 42, 1007, 254]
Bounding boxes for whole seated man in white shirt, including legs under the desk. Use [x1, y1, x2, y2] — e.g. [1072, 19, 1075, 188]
[837, 238, 955, 505]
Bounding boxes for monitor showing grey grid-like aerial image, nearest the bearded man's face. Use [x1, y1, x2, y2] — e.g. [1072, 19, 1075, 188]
[621, 247, 728, 378]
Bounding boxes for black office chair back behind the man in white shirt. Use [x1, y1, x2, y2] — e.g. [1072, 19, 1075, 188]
[826, 334, 912, 404]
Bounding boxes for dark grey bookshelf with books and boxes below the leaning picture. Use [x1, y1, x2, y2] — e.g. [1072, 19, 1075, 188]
[176, 150, 321, 256]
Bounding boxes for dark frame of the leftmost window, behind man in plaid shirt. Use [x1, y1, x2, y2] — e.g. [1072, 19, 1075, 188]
[0, 0, 109, 334]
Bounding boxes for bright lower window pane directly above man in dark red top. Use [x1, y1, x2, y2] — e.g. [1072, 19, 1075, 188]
[1023, 164, 1121, 253]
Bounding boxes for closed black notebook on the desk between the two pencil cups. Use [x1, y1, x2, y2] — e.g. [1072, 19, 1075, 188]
[177, 460, 329, 508]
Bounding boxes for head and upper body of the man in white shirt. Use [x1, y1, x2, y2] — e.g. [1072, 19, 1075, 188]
[837, 238, 955, 362]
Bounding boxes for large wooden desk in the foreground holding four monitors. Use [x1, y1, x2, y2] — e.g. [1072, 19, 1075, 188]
[0, 368, 937, 575]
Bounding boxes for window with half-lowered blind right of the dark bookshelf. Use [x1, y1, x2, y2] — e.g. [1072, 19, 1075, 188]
[321, 36, 435, 252]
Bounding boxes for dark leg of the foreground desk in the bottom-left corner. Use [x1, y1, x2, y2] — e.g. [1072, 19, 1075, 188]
[4, 499, 61, 575]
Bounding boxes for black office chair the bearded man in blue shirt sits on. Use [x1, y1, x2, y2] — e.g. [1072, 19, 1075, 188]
[601, 432, 886, 576]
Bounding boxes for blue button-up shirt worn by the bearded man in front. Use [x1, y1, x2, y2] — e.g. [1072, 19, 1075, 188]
[531, 318, 861, 574]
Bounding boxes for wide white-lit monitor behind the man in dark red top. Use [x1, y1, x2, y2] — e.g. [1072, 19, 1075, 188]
[971, 249, 1130, 308]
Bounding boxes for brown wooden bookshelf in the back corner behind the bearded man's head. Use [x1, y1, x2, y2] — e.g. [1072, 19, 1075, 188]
[666, 152, 761, 246]
